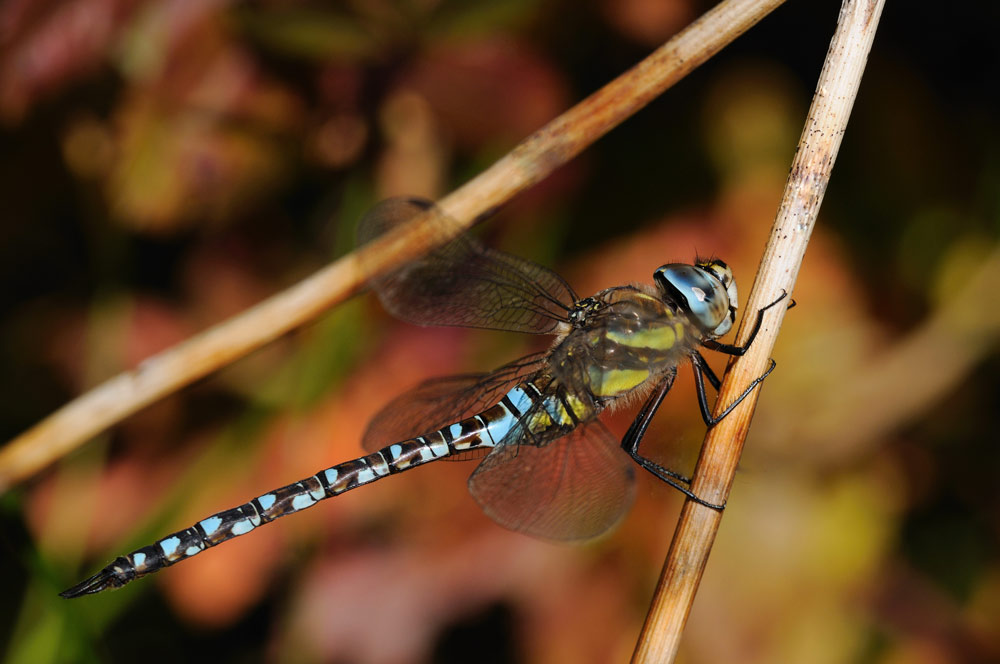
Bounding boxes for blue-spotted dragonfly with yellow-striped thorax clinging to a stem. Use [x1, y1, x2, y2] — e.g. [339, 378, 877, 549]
[60, 197, 785, 598]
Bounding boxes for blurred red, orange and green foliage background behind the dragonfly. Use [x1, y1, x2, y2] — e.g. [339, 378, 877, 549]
[0, 0, 1000, 664]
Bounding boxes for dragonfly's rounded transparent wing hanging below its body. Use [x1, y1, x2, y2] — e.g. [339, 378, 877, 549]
[469, 420, 635, 541]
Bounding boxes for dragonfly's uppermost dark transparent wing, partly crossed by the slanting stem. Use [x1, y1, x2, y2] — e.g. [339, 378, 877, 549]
[358, 198, 576, 334]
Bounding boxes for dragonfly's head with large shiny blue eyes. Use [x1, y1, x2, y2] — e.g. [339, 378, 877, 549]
[653, 258, 737, 337]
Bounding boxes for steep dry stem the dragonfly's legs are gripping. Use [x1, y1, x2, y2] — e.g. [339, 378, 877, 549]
[632, 0, 885, 662]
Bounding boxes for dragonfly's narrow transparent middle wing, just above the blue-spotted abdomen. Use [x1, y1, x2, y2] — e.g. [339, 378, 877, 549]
[361, 353, 546, 452]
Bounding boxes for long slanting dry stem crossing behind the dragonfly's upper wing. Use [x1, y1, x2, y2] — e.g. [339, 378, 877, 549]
[0, 0, 784, 491]
